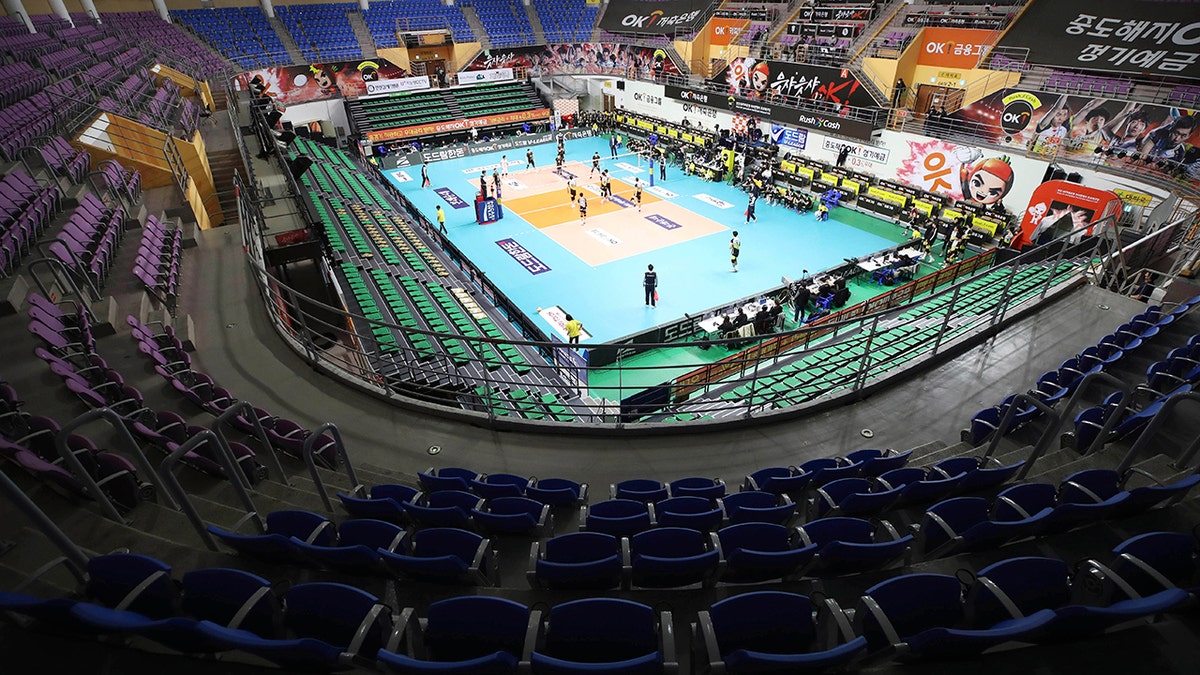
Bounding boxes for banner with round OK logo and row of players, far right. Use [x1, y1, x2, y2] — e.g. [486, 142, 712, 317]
[950, 89, 1200, 184]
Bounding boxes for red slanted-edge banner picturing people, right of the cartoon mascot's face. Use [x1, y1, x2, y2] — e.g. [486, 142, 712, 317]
[1013, 180, 1121, 249]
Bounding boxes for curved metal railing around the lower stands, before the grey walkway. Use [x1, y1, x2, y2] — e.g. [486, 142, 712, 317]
[236, 165, 1142, 429]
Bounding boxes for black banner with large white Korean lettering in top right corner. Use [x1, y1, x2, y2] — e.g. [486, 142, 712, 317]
[1000, 0, 1200, 78]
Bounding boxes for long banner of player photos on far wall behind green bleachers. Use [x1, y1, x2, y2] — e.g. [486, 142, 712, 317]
[458, 42, 679, 80]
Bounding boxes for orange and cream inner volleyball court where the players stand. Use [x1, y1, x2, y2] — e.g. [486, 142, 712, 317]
[492, 162, 728, 267]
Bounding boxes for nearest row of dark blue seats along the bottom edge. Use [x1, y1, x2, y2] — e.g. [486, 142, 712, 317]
[0, 532, 1200, 673]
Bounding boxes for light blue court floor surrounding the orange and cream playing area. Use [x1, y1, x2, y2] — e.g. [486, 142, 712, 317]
[384, 137, 901, 342]
